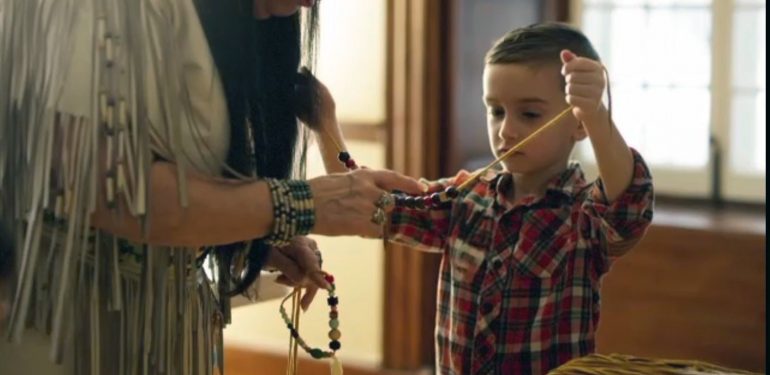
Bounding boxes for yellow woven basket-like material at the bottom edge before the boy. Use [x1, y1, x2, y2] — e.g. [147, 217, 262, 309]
[548, 354, 759, 375]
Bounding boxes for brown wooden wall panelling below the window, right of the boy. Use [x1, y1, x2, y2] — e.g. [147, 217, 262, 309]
[597, 210, 766, 372]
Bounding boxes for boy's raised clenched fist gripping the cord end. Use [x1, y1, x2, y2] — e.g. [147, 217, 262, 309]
[560, 50, 607, 124]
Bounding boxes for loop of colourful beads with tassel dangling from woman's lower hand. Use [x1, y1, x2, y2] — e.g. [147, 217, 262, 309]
[279, 274, 342, 374]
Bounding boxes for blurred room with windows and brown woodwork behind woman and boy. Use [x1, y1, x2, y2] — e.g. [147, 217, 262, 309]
[225, 0, 766, 375]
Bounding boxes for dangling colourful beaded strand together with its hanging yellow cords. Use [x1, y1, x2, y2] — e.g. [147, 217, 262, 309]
[279, 274, 342, 375]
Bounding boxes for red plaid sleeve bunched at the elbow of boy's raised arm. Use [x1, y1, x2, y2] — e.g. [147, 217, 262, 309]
[582, 149, 654, 257]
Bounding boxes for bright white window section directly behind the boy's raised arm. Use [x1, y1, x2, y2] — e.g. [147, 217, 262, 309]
[581, 1, 712, 169]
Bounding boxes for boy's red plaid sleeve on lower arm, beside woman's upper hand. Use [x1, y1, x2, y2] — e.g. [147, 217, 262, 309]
[388, 171, 470, 252]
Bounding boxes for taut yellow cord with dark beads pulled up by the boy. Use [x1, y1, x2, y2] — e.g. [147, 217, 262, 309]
[324, 106, 573, 209]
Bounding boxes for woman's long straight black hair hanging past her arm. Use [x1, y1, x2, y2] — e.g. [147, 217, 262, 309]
[195, 0, 318, 296]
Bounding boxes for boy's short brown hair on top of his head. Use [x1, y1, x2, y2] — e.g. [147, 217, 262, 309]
[485, 22, 600, 65]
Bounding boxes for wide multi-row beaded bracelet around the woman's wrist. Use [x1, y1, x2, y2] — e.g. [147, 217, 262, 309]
[265, 178, 315, 247]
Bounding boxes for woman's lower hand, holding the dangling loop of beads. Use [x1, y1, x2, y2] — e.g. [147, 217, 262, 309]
[265, 237, 331, 311]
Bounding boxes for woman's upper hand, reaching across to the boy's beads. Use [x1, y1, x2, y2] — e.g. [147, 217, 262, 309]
[308, 169, 425, 238]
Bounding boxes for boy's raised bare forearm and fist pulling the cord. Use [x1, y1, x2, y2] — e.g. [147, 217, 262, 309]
[561, 50, 634, 203]
